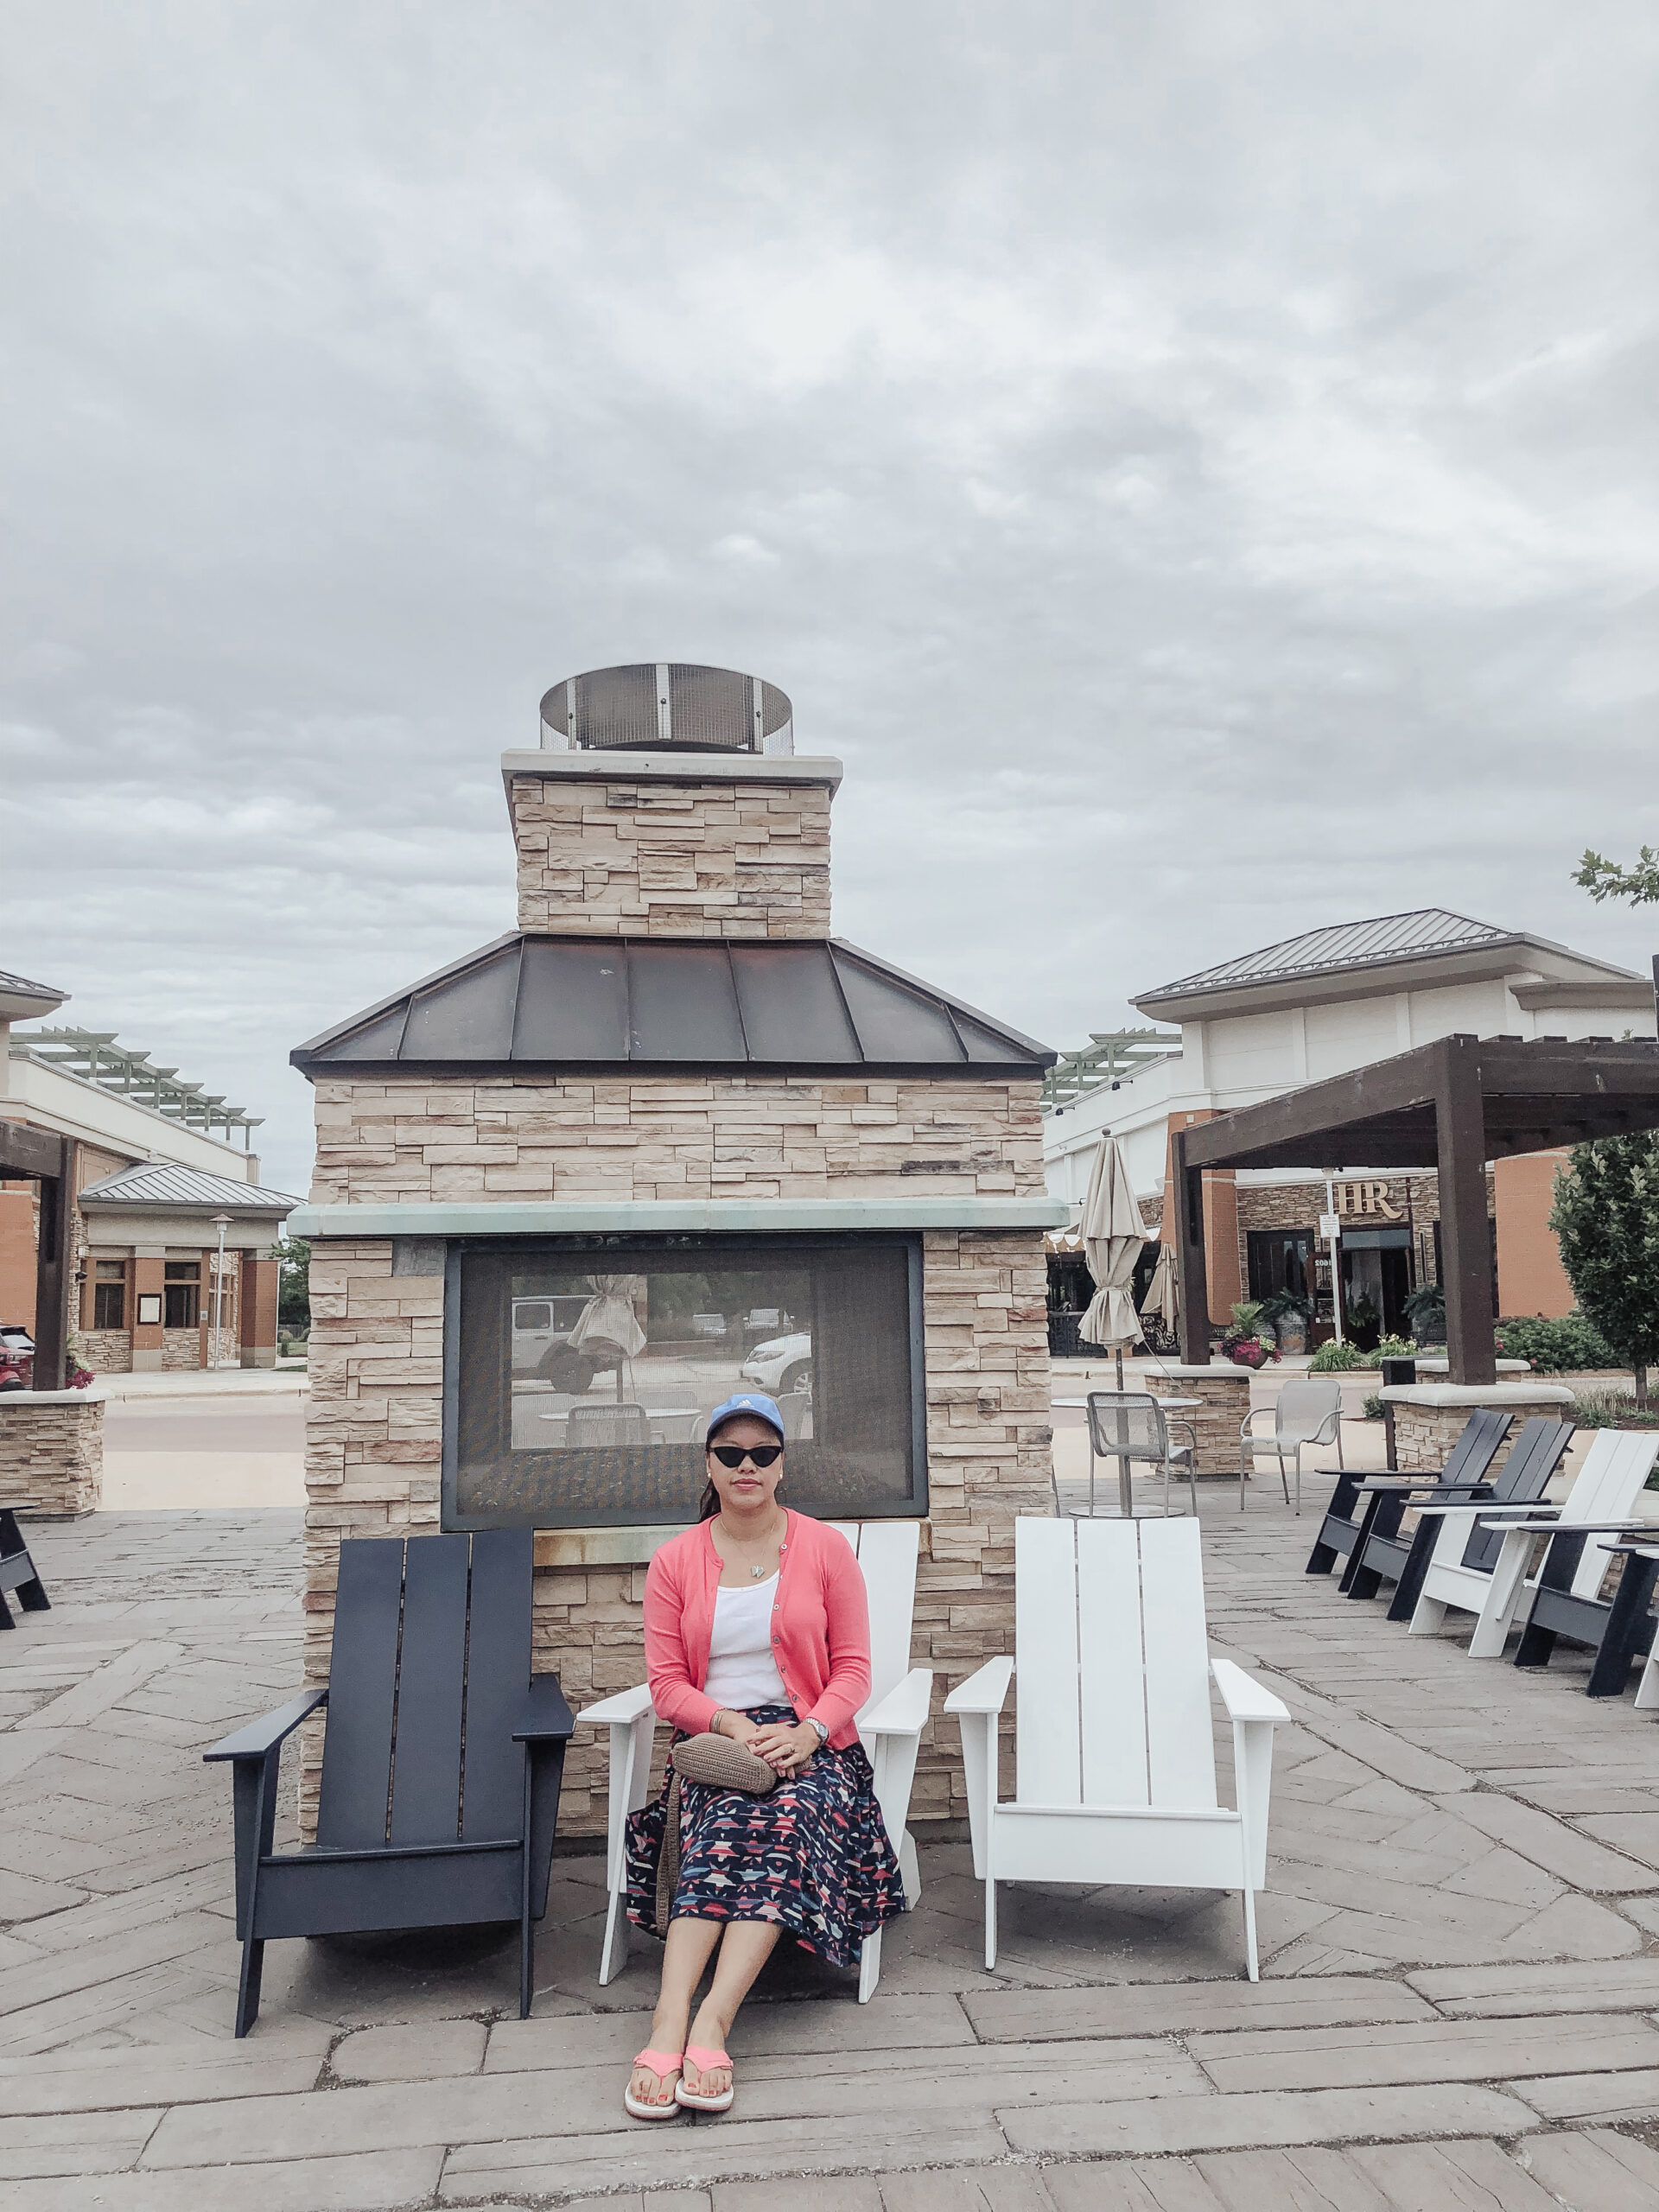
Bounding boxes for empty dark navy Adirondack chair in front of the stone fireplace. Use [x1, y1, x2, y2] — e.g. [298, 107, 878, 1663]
[206, 1529, 575, 2035]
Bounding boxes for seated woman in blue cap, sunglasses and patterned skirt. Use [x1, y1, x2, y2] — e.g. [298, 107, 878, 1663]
[624, 1394, 905, 2119]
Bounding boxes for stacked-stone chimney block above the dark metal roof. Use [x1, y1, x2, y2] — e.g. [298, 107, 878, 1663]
[506, 774, 832, 938]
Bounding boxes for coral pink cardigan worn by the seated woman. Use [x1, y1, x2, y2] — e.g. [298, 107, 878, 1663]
[646, 1513, 869, 1752]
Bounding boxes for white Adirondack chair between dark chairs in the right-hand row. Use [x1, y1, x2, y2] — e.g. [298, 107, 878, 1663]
[1411, 1429, 1659, 1659]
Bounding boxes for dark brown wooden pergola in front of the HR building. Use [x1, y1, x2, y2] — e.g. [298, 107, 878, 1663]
[1170, 1035, 1659, 1382]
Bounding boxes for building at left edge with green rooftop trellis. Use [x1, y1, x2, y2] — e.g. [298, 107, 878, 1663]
[0, 976, 296, 1374]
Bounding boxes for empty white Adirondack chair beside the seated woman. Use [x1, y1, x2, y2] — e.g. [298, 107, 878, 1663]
[944, 1516, 1289, 1982]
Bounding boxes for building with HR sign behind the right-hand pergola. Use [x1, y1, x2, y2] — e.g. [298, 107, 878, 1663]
[1044, 909, 1655, 1343]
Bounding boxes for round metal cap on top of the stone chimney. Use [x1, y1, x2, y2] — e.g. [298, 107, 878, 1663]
[542, 661, 794, 754]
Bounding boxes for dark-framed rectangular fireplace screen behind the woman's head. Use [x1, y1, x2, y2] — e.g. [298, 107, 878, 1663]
[445, 1236, 927, 1529]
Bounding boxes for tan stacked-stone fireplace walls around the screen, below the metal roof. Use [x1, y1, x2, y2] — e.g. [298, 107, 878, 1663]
[305, 1077, 1053, 1836]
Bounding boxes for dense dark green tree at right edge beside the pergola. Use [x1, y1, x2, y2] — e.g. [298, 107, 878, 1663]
[1551, 1130, 1659, 1407]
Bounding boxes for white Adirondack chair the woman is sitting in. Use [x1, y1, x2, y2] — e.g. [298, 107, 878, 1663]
[577, 1520, 933, 2004]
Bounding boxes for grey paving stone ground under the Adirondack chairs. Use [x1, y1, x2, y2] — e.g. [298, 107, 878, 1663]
[0, 1480, 1659, 2212]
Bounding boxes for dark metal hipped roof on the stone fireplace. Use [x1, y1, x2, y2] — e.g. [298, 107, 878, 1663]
[289, 933, 1055, 1077]
